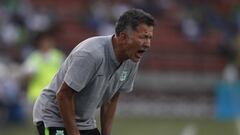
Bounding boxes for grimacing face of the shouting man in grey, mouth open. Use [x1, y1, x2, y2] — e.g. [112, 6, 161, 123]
[125, 24, 153, 62]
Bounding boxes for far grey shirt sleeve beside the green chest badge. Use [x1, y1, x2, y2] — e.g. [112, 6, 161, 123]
[119, 63, 139, 93]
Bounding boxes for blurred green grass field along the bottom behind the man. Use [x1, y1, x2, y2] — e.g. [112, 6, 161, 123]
[0, 117, 236, 135]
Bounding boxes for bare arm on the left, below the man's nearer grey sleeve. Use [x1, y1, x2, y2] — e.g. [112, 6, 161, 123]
[57, 82, 80, 135]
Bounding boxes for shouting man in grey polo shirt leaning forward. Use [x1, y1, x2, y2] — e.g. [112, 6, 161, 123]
[33, 9, 154, 135]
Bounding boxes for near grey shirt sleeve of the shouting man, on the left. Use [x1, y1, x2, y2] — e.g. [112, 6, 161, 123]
[64, 52, 97, 92]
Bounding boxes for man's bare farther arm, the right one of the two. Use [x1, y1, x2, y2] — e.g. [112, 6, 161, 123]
[100, 93, 119, 135]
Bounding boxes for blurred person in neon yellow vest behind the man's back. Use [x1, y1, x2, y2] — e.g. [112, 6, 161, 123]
[23, 33, 64, 103]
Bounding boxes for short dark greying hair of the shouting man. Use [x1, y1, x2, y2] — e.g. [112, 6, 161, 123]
[115, 9, 155, 36]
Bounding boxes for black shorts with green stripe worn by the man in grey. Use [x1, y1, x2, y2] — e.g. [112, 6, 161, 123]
[37, 121, 101, 135]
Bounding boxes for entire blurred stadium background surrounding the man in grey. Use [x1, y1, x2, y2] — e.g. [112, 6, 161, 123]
[0, 0, 240, 135]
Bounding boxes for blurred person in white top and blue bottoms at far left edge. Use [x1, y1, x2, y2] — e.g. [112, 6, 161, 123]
[0, 59, 24, 124]
